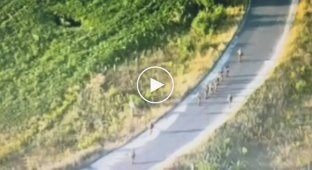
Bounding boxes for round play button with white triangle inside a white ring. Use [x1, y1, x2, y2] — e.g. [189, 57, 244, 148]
[137, 66, 174, 104]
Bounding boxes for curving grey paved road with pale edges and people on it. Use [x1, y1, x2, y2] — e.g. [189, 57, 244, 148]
[85, 0, 296, 170]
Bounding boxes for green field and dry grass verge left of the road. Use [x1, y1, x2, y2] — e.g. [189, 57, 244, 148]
[0, 0, 245, 169]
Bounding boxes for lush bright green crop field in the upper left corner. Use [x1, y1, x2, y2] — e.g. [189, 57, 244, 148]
[0, 0, 194, 131]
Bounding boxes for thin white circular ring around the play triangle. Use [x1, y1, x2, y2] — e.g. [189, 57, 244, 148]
[137, 66, 174, 104]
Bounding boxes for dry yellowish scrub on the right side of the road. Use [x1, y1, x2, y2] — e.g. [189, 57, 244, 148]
[170, 0, 312, 170]
